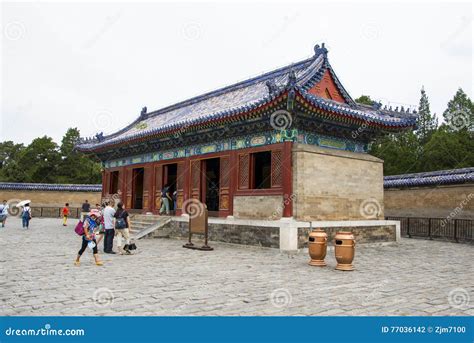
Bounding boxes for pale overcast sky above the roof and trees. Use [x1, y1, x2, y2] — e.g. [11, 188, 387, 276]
[0, 1, 473, 143]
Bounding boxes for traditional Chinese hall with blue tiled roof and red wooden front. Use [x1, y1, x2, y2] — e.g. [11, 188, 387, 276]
[77, 44, 417, 250]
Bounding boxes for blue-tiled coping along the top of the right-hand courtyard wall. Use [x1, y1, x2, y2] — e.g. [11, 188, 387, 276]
[384, 168, 474, 188]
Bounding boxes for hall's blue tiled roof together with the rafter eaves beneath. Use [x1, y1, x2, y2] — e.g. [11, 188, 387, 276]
[76, 43, 417, 152]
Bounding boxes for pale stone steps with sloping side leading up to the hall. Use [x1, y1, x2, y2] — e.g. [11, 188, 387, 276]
[130, 214, 171, 239]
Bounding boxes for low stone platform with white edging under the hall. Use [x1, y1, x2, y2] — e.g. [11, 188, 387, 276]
[148, 215, 400, 252]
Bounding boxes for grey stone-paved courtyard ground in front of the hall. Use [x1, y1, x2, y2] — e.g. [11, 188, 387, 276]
[0, 218, 474, 316]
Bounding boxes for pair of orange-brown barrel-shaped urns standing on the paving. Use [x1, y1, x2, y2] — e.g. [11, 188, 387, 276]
[308, 229, 355, 270]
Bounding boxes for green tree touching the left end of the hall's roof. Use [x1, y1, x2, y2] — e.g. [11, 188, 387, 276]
[58, 128, 101, 183]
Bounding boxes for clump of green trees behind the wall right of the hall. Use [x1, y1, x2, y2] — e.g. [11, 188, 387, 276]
[369, 88, 474, 175]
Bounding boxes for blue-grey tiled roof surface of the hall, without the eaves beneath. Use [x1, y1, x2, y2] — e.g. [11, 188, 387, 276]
[77, 45, 416, 151]
